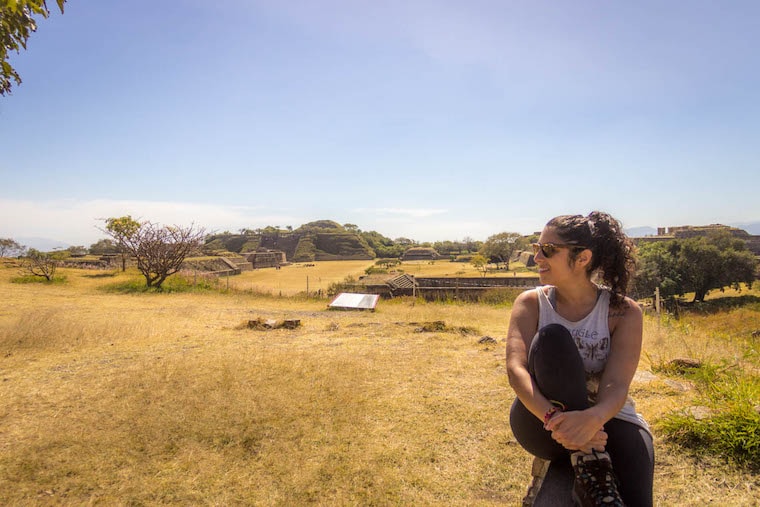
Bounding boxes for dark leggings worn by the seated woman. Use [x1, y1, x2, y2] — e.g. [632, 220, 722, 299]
[509, 324, 654, 506]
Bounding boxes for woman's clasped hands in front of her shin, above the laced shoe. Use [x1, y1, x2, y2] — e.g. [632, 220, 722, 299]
[544, 410, 607, 452]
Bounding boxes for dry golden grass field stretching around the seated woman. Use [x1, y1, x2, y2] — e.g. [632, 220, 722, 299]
[0, 262, 760, 506]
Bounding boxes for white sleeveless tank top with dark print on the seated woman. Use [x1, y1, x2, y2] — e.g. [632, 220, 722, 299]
[536, 286, 651, 433]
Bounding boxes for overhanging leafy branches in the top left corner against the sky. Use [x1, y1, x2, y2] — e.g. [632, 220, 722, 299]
[0, 0, 66, 95]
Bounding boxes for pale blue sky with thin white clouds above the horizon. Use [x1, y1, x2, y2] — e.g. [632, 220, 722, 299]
[0, 0, 760, 245]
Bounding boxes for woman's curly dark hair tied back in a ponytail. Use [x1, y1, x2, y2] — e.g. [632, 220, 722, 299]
[546, 211, 636, 303]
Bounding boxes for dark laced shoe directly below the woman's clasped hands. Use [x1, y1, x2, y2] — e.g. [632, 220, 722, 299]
[570, 451, 625, 507]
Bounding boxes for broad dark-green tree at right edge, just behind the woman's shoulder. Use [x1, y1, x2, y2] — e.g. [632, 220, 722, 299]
[634, 234, 757, 301]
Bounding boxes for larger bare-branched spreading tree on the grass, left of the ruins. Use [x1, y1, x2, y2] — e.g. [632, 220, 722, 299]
[104, 216, 206, 288]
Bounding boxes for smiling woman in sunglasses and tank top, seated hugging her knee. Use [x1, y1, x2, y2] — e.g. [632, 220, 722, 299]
[507, 211, 654, 506]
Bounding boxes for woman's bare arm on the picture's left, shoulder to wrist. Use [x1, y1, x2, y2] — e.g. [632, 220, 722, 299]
[507, 290, 553, 421]
